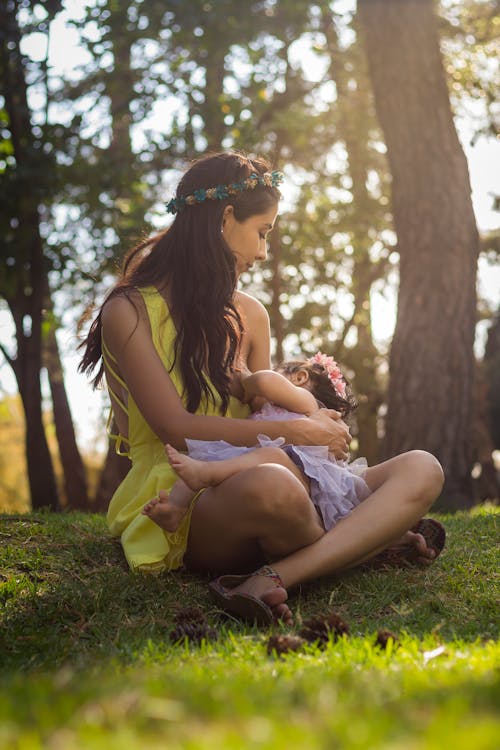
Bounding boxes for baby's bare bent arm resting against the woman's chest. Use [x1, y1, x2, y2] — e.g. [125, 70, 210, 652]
[241, 370, 318, 416]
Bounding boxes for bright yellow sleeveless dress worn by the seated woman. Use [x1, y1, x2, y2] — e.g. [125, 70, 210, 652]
[102, 287, 249, 572]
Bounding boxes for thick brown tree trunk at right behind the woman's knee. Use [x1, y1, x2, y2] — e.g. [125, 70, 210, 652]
[358, 0, 479, 509]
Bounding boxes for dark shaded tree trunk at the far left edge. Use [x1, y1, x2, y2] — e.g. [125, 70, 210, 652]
[0, 2, 59, 510]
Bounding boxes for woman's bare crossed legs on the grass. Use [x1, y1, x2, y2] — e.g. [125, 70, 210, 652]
[187, 451, 443, 596]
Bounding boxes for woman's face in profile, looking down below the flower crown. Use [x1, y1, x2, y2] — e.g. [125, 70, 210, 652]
[222, 206, 278, 275]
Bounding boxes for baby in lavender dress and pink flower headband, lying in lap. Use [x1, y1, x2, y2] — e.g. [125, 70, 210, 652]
[142, 352, 370, 531]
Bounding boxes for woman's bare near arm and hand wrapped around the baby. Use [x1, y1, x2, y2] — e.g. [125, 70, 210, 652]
[102, 295, 349, 456]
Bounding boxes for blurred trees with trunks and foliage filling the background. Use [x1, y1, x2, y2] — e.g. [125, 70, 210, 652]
[0, 0, 500, 509]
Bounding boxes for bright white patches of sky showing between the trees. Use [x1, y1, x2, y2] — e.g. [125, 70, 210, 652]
[0, 0, 500, 453]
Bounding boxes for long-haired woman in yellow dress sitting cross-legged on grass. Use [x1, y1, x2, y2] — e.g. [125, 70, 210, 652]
[80, 152, 443, 622]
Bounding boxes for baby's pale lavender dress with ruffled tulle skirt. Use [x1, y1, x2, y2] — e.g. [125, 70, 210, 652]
[186, 404, 371, 531]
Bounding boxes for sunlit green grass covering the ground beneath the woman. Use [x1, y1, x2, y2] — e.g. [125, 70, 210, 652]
[0, 506, 500, 750]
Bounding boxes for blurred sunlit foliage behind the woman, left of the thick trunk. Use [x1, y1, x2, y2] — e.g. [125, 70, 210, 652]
[0, 0, 498, 512]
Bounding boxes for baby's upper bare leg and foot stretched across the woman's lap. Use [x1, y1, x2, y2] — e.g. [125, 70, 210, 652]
[165, 445, 309, 492]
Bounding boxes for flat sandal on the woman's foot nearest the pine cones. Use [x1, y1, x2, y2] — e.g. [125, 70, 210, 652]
[208, 565, 285, 625]
